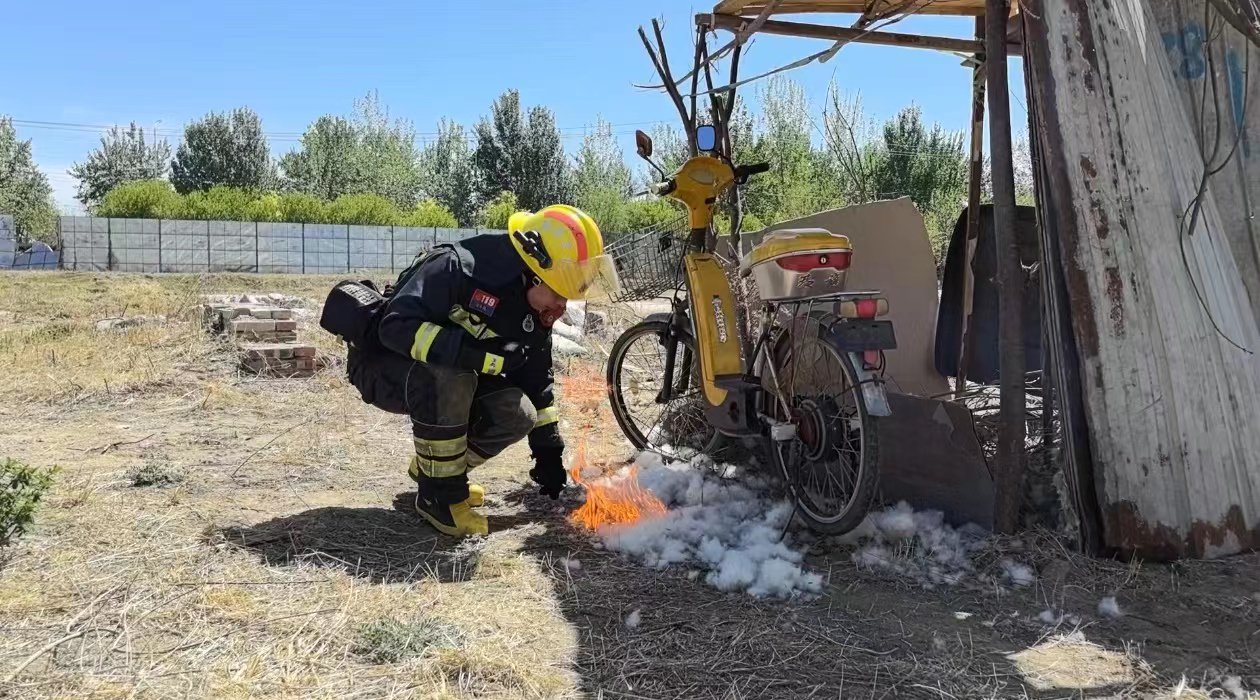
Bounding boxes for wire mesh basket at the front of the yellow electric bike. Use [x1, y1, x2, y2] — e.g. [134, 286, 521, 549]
[607, 217, 690, 301]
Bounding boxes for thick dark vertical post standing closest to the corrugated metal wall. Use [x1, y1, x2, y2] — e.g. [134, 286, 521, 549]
[984, 0, 1027, 533]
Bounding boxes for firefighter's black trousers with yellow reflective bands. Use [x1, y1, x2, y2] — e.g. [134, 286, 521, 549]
[347, 347, 538, 504]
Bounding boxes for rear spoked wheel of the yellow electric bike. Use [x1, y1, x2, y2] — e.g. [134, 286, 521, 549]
[762, 316, 879, 534]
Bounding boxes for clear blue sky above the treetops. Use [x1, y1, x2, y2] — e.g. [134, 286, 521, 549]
[0, 0, 1027, 209]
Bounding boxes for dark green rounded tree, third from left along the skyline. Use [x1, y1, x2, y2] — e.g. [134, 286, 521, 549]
[170, 107, 276, 194]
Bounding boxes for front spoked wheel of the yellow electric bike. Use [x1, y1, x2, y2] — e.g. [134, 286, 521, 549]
[607, 321, 722, 458]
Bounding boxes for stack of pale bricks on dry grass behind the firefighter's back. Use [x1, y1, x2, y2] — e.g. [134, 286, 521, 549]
[204, 297, 324, 376]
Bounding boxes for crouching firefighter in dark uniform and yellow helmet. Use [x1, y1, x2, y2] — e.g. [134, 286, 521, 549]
[348, 205, 616, 536]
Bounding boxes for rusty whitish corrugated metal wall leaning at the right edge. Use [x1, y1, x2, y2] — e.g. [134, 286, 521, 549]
[1026, 0, 1260, 559]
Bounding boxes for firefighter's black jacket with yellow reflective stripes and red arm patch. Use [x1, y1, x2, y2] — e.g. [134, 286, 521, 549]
[379, 233, 564, 454]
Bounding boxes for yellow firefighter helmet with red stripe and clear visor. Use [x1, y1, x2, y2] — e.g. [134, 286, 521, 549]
[508, 204, 617, 300]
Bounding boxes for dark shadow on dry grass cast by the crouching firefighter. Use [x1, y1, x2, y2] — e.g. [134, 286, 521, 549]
[213, 491, 478, 583]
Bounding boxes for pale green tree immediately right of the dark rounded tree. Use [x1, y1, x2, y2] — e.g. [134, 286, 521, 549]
[280, 115, 363, 200]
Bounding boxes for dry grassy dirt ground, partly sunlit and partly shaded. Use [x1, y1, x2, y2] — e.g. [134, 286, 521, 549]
[0, 273, 1260, 699]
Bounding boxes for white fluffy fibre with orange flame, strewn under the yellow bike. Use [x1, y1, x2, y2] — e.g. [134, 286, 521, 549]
[575, 452, 1036, 598]
